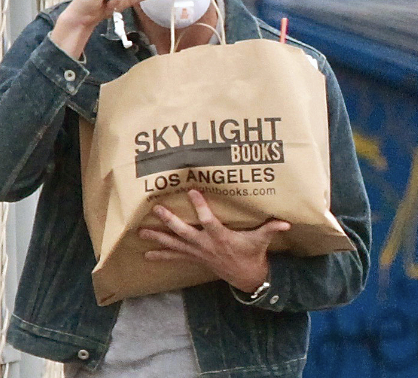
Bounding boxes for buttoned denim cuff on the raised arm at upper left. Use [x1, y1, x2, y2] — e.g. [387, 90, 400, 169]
[31, 34, 89, 95]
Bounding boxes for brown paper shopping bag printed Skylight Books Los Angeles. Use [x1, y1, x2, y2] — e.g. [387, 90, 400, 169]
[81, 40, 355, 305]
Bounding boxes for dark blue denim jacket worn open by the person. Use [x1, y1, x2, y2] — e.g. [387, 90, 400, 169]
[0, 0, 370, 378]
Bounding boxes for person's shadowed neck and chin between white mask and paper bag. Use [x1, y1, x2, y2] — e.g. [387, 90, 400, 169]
[134, 4, 218, 54]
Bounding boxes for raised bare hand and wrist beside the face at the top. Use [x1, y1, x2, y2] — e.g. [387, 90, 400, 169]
[51, 0, 140, 59]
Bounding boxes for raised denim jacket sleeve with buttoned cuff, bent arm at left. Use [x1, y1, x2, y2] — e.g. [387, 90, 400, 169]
[0, 14, 88, 201]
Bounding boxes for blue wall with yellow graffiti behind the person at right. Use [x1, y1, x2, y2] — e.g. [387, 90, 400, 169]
[258, 0, 418, 378]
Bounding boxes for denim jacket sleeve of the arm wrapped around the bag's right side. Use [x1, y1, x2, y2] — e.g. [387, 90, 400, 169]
[232, 54, 371, 312]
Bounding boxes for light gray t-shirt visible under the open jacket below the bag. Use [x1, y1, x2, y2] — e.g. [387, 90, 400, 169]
[65, 291, 198, 378]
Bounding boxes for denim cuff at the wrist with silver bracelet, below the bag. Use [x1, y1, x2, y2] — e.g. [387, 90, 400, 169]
[229, 253, 290, 312]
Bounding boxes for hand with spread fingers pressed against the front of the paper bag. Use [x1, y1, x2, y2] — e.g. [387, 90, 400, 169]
[139, 190, 290, 292]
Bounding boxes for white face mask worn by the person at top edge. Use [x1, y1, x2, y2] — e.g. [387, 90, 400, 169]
[139, 0, 211, 29]
